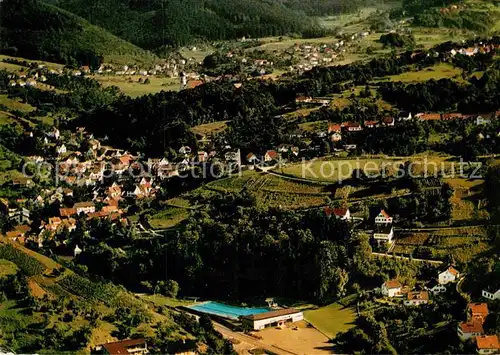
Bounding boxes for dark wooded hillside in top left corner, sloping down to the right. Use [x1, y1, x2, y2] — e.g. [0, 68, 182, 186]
[0, 0, 154, 65]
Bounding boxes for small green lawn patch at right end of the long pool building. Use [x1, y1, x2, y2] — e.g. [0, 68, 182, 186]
[304, 303, 356, 338]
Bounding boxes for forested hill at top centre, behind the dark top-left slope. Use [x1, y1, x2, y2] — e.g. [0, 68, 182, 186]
[47, 0, 328, 49]
